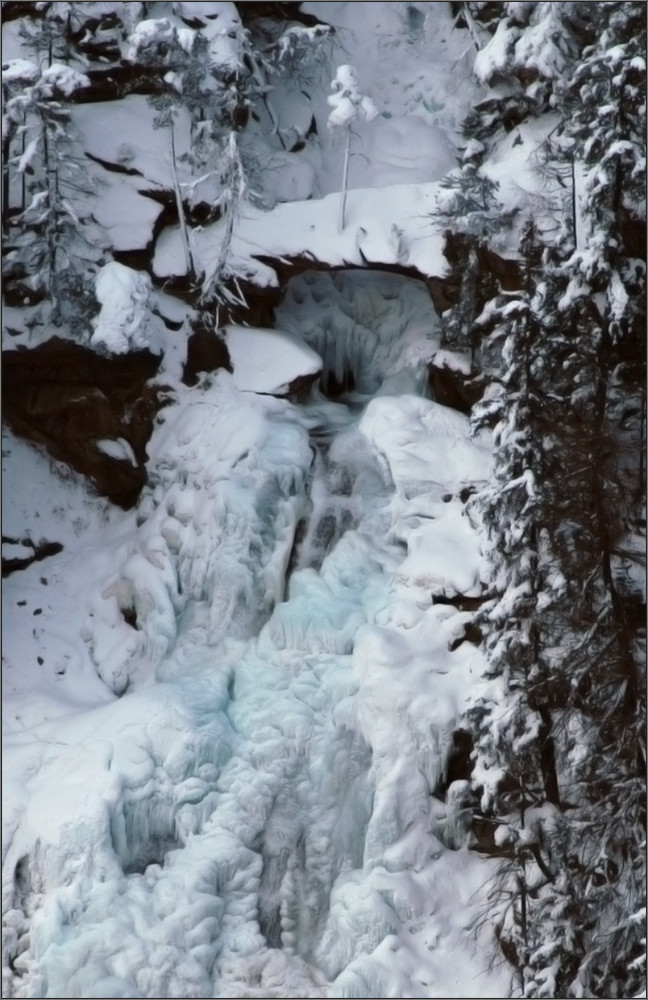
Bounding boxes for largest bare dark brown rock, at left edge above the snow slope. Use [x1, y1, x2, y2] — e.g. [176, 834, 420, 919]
[2, 337, 166, 509]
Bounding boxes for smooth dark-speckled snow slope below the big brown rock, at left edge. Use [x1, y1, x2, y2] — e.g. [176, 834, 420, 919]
[2, 428, 134, 734]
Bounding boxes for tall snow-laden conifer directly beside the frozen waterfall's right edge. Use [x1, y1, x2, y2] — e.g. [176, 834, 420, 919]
[469, 215, 645, 997]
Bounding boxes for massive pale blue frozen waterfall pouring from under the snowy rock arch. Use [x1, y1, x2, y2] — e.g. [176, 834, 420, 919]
[4, 272, 502, 998]
